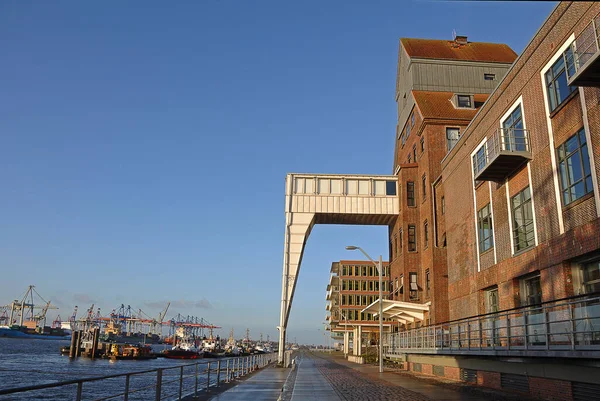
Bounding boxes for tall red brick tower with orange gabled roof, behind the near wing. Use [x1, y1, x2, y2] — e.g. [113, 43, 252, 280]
[390, 37, 517, 327]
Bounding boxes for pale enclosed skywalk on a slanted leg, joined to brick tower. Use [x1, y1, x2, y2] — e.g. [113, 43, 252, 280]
[278, 174, 400, 362]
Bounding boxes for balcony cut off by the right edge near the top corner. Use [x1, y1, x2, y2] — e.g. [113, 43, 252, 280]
[566, 14, 600, 87]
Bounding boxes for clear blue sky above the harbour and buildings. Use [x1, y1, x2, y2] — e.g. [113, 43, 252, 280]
[0, 0, 555, 342]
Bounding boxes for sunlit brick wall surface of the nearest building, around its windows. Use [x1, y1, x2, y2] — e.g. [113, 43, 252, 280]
[442, 2, 600, 319]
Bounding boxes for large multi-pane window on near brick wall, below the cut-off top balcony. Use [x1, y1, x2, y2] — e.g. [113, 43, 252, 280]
[557, 128, 593, 206]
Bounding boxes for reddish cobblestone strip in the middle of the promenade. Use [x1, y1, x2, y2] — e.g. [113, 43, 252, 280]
[306, 355, 430, 401]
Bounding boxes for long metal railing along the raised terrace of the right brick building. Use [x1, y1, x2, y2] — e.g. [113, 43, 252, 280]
[384, 294, 600, 357]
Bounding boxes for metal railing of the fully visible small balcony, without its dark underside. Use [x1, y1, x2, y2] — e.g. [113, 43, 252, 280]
[473, 128, 531, 177]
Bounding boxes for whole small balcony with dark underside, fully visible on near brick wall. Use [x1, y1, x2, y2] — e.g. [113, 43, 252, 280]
[473, 128, 531, 182]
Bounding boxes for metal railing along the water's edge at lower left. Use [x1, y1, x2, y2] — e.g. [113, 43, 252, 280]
[0, 353, 277, 401]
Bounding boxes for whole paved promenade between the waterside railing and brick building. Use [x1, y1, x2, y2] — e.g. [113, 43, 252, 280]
[203, 353, 523, 401]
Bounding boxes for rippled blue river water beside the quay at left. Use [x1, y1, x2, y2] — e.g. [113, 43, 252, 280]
[0, 338, 244, 401]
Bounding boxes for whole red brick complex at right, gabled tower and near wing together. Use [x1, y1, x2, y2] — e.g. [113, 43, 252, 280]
[387, 2, 600, 400]
